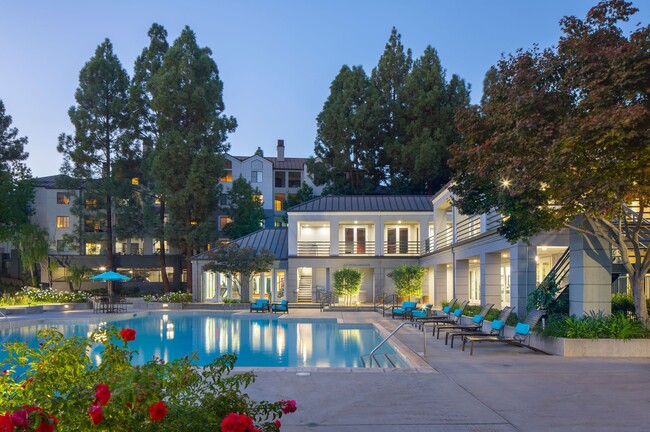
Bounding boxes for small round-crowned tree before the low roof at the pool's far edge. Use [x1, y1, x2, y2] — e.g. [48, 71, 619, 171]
[203, 243, 275, 302]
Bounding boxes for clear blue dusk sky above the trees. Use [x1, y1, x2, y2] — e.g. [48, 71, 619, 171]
[0, 0, 650, 176]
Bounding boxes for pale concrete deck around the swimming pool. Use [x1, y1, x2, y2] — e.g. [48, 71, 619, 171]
[1, 310, 650, 432]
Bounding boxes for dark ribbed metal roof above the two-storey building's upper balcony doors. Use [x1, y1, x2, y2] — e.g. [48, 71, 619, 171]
[287, 195, 433, 212]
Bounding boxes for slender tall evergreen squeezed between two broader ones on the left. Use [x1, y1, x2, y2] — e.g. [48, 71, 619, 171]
[129, 23, 170, 292]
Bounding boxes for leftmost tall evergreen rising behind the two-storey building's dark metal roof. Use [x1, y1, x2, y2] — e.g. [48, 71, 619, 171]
[308, 66, 383, 194]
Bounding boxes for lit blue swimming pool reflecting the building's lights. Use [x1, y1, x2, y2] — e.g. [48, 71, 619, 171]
[0, 312, 409, 368]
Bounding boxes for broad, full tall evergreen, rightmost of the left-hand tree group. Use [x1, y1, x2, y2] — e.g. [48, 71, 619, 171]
[151, 27, 237, 287]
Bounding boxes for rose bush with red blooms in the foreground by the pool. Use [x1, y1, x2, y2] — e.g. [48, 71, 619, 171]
[0, 327, 296, 432]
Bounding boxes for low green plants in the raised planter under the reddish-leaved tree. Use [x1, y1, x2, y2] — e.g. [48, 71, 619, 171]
[542, 312, 650, 339]
